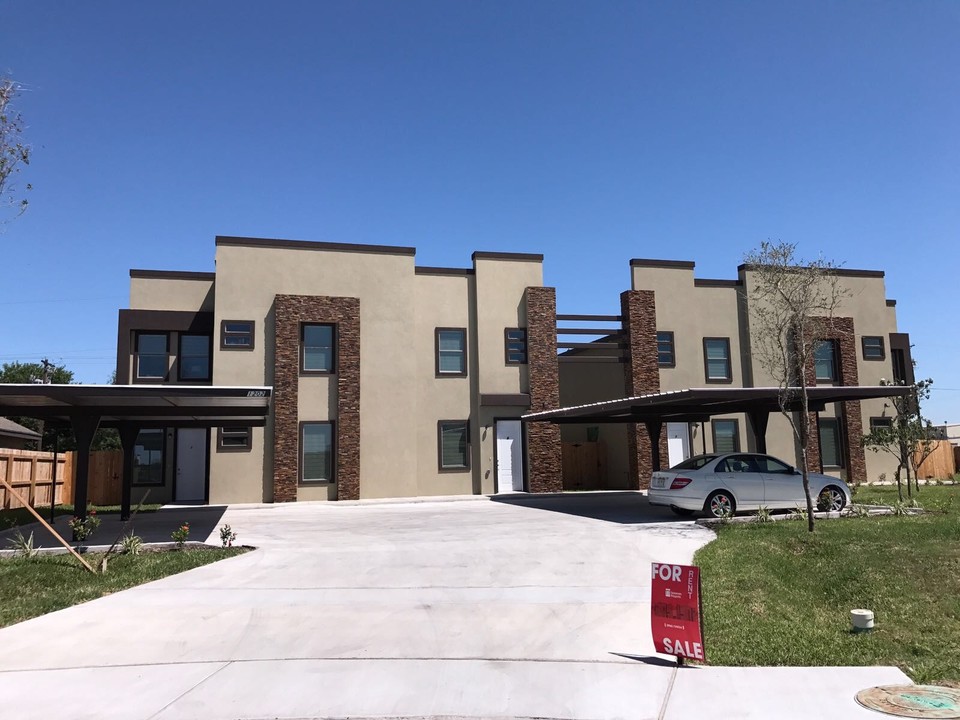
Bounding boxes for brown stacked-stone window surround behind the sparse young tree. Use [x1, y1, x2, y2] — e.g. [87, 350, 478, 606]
[804, 317, 867, 482]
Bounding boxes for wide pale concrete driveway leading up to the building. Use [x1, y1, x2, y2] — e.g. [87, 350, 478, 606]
[0, 493, 907, 720]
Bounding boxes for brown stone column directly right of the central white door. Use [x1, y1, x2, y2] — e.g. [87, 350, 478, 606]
[525, 287, 563, 493]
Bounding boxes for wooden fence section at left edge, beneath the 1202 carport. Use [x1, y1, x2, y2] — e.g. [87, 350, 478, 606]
[0, 448, 74, 510]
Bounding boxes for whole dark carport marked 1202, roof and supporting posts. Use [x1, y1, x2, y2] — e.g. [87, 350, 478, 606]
[0, 384, 273, 519]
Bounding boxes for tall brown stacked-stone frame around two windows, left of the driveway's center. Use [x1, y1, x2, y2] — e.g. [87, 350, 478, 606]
[273, 295, 360, 502]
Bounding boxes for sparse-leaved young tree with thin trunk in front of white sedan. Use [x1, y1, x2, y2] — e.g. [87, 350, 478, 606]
[744, 242, 849, 532]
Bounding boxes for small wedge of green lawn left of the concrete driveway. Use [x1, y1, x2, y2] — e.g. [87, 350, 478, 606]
[0, 548, 247, 627]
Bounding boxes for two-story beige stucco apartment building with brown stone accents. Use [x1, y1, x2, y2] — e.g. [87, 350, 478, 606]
[117, 237, 910, 503]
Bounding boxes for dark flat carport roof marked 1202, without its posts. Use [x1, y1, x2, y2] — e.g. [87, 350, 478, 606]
[0, 384, 273, 427]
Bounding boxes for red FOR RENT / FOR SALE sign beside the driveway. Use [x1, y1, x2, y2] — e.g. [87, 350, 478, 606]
[650, 563, 707, 662]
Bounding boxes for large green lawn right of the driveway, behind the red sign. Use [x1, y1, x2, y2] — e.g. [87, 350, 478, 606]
[695, 486, 960, 686]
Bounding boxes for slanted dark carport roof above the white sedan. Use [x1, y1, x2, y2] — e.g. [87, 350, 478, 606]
[522, 385, 910, 424]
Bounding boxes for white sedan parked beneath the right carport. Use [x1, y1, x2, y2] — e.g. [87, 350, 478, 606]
[648, 453, 850, 517]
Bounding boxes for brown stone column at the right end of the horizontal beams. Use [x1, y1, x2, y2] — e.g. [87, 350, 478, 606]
[620, 290, 668, 490]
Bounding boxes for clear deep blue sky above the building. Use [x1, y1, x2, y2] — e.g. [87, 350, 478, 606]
[0, 0, 960, 422]
